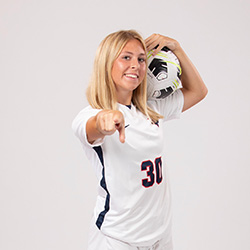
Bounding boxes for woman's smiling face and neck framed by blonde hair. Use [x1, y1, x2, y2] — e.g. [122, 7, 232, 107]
[111, 39, 146, 105]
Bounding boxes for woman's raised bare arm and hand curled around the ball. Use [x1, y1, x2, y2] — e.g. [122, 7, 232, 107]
[145, 34, 207, 111]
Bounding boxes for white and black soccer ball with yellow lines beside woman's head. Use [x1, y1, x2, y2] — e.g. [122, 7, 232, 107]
[147, 47, 181, 100]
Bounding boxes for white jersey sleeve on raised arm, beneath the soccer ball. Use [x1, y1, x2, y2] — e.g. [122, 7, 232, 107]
[148, 89, 184, 121]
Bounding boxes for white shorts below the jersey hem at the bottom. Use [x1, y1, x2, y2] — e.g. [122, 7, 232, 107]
[87, 223, 173, 250]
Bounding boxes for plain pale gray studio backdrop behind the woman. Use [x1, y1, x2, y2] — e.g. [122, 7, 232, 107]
[0, 0, 250, 250]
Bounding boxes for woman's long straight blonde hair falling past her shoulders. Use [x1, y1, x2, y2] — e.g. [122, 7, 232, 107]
[86, 30, 163, 122]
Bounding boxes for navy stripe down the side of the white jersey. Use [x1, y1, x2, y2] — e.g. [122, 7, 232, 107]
[93, 146, 110, 229]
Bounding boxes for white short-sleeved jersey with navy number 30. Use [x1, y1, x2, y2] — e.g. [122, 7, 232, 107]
[72, 90, 184, 246]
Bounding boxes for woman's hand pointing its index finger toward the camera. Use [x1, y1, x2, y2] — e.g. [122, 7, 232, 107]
[96, 110, 125, 143]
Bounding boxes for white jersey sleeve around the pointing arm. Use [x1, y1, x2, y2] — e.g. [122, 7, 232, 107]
[72, 106, 104, 147]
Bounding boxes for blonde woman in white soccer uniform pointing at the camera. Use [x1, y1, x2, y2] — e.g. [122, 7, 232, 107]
[72, 30, 207, 250]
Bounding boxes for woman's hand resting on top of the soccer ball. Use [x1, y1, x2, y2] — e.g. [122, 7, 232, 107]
[145, 34, 180, 56]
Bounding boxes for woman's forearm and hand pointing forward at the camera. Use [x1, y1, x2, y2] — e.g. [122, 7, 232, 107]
[86, 110, 125, 144]
